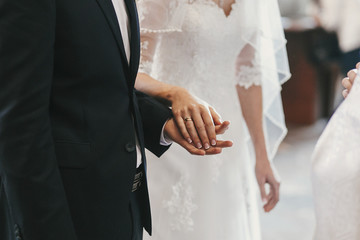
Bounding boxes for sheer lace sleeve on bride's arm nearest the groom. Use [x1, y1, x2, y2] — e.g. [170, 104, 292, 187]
[137, 0, 185, 75]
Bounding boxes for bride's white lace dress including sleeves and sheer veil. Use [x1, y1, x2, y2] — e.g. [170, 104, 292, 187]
[138, 0, 289, 240]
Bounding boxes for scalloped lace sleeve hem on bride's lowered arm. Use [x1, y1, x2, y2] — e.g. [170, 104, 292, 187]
[236, 66, 261, 89]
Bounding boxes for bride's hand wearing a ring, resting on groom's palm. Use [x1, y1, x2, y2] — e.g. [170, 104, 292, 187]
[171, 87, 230, 150]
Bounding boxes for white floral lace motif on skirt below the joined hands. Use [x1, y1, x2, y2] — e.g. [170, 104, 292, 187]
[163, 176, 198, 232]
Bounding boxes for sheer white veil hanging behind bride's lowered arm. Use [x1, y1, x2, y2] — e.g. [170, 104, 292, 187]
[237, 0, 291, 159]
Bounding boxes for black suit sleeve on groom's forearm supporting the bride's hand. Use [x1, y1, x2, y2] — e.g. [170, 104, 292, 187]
[136, 91, 172, 157]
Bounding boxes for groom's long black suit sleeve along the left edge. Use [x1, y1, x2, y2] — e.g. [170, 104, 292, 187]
[0, 0, 77, 240]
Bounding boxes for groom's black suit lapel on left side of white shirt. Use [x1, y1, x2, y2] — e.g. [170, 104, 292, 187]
[96, 0, 128, 71]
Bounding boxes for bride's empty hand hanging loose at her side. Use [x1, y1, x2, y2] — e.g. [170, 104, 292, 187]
[255, 157, 280, 212]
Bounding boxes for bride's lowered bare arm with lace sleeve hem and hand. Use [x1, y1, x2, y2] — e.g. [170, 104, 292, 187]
[236, 45, 280, 212]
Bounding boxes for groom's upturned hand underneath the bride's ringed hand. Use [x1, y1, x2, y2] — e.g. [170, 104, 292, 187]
[164, 119, 233, 155]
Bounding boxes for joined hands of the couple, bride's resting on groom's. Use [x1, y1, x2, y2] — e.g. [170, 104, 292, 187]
[164, 88, 232, 155]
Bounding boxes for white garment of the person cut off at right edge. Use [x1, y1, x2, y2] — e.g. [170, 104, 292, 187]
[312, 74, 360, 240]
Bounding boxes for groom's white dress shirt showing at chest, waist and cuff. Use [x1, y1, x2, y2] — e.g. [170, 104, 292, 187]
[112, 0, 172, 167]
